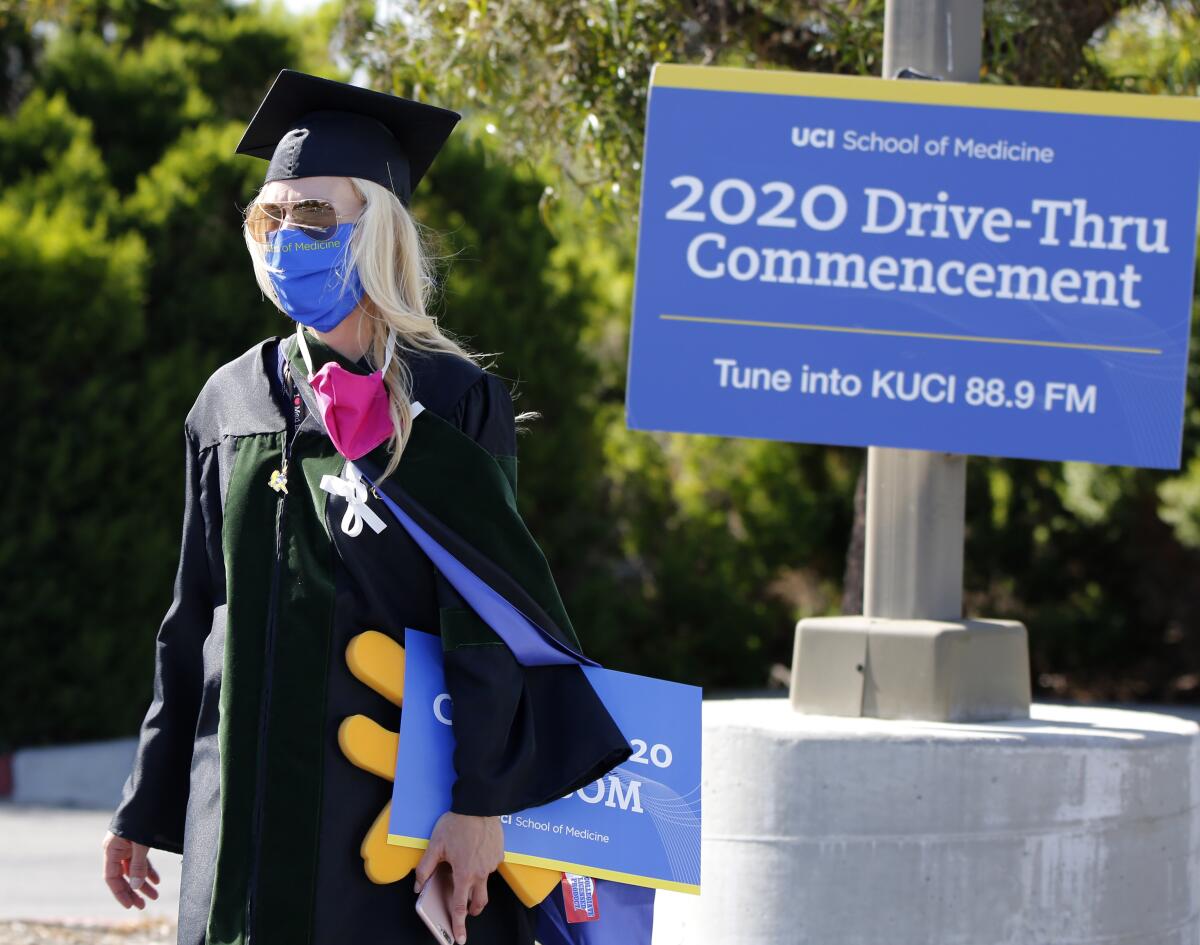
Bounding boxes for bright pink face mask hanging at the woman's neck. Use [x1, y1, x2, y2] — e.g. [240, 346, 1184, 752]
[296, 325, 396, 459]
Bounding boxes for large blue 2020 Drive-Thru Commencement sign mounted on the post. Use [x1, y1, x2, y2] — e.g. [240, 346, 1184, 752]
[626, 65, 1200, 469]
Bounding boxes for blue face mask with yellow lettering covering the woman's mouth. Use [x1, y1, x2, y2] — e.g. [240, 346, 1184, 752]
[266, 223, 362, 331]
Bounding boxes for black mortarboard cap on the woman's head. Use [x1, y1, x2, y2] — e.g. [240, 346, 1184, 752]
[236, 68, 462, 206]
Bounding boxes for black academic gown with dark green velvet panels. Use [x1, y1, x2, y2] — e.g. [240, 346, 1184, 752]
[110, 336, 631, 945]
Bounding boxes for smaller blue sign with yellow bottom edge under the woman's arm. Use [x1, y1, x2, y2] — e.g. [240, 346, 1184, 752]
[388, 628, 701, 893]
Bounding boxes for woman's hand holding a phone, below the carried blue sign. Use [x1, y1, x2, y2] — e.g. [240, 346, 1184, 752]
[416, 811, 504, 945]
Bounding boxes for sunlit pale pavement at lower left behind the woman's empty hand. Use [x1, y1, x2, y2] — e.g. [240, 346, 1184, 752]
[0, 803, 180, 945]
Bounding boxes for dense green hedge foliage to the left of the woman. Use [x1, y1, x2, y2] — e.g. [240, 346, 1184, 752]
[0, 0, 314, 744]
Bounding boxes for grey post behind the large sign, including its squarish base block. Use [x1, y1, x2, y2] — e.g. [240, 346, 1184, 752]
[791, 0, 1031, 721]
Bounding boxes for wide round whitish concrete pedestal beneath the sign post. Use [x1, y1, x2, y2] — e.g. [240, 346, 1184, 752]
[654, 699, 1200, 945]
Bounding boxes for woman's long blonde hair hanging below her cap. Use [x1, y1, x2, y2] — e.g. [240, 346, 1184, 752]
[242, 177, 508, 481]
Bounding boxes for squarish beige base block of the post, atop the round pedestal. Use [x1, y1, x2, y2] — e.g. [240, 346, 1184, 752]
[792, 616, 1031, 722]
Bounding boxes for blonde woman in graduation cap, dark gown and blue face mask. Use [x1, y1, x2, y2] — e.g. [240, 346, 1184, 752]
[104, 70, 630, 945]
